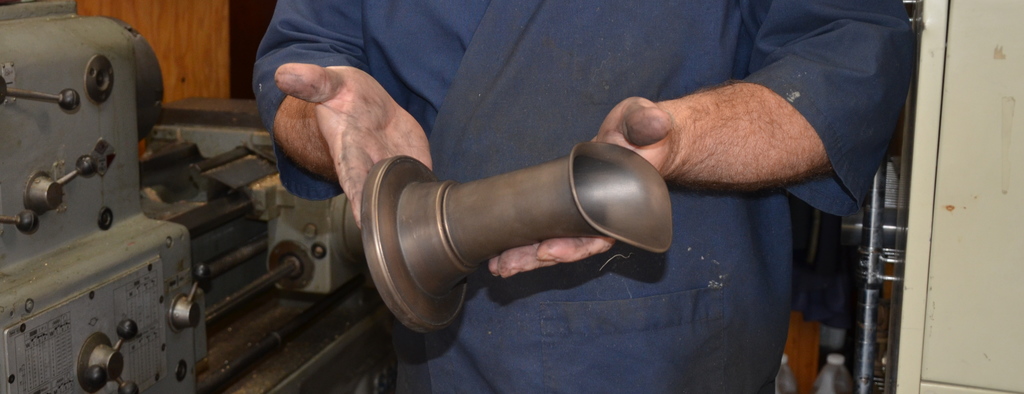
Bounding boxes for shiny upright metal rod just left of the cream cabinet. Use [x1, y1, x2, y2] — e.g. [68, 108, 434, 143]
[853, 163, 886, 394]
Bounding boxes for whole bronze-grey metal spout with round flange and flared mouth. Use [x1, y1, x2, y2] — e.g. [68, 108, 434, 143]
[362, 142, 672, 333]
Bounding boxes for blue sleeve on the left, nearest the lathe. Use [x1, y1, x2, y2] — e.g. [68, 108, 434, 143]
[253, 0, 367, 200]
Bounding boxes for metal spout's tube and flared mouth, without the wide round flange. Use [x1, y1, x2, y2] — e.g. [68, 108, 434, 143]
[444, 142, 672, 269]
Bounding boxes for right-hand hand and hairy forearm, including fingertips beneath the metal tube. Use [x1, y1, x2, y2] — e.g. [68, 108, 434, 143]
[488, 83, 831, 277]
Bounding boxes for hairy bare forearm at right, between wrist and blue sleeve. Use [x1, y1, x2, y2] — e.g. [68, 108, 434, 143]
[658, 83, 831, 190]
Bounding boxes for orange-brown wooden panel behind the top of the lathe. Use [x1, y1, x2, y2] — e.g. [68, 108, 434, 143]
[78, 0, 230, 102]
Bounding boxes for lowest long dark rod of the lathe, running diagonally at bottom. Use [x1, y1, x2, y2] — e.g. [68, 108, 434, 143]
[196, 274, 364, 394]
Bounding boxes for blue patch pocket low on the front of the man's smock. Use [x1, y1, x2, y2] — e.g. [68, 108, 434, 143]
[541, 289, 725, 393]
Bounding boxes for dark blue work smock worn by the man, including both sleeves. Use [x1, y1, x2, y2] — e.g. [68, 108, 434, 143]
[253, 0, 913, 393]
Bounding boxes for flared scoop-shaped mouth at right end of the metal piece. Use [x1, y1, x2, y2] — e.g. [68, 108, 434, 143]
[569, 142, 672, 253]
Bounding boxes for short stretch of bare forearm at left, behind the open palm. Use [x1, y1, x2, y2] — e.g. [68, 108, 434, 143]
[273, 96, 338, 180]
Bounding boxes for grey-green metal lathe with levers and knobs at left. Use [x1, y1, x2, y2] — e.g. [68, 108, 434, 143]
[0, 1, 394, 388]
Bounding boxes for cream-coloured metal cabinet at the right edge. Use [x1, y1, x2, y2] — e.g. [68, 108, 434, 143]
[895, 0, 1024, 388]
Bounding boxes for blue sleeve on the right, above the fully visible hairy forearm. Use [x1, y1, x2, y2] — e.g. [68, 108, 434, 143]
[742, 0, 913, 215]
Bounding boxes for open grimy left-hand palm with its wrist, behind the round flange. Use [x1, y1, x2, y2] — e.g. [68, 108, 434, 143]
[274, 63, 431, 225]
